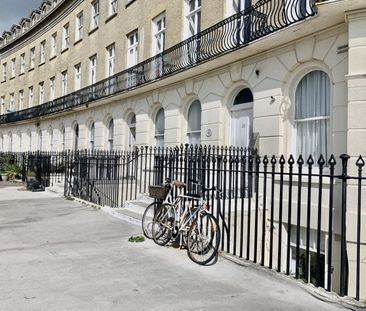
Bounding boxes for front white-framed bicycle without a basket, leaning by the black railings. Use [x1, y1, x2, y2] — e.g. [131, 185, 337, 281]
[152, 182, 220, 265]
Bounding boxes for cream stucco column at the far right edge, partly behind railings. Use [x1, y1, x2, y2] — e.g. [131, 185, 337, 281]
[346, 10, 366, 299]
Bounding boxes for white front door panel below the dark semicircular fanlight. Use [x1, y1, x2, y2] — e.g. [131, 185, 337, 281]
[231, 105, 253, 148]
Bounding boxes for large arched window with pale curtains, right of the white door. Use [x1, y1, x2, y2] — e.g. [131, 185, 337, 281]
[295, 70, 330, 162]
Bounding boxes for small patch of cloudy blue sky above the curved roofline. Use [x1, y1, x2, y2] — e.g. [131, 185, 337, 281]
[0, 0, 42, 35]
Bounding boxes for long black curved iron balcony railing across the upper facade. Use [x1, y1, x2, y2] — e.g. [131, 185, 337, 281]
[0, 0, 316, 124]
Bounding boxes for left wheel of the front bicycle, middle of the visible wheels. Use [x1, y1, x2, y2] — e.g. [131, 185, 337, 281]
[152, 204, 174, 246]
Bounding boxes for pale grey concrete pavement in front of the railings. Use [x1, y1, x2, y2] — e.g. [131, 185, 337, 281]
[0, 187, 354, 311]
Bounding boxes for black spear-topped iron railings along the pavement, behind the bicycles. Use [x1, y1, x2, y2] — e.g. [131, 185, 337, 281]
[0, 145, 366, 300]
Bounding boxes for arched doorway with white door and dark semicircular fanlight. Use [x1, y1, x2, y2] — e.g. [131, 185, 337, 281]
[230, 88, 253, 148]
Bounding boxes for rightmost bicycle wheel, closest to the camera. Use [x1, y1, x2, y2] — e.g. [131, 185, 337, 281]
[187, 213, 220, 265]
